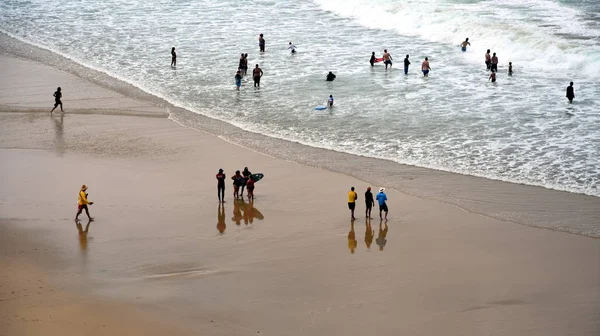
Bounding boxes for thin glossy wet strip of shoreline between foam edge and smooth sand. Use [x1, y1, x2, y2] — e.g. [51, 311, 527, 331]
[0, 33, 600, 238]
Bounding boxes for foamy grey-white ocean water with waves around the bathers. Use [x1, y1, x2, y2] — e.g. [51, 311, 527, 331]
[0, 0, 600, 196]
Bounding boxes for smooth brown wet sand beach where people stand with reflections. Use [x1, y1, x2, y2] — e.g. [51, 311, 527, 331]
[0, 56, 600, 335]
